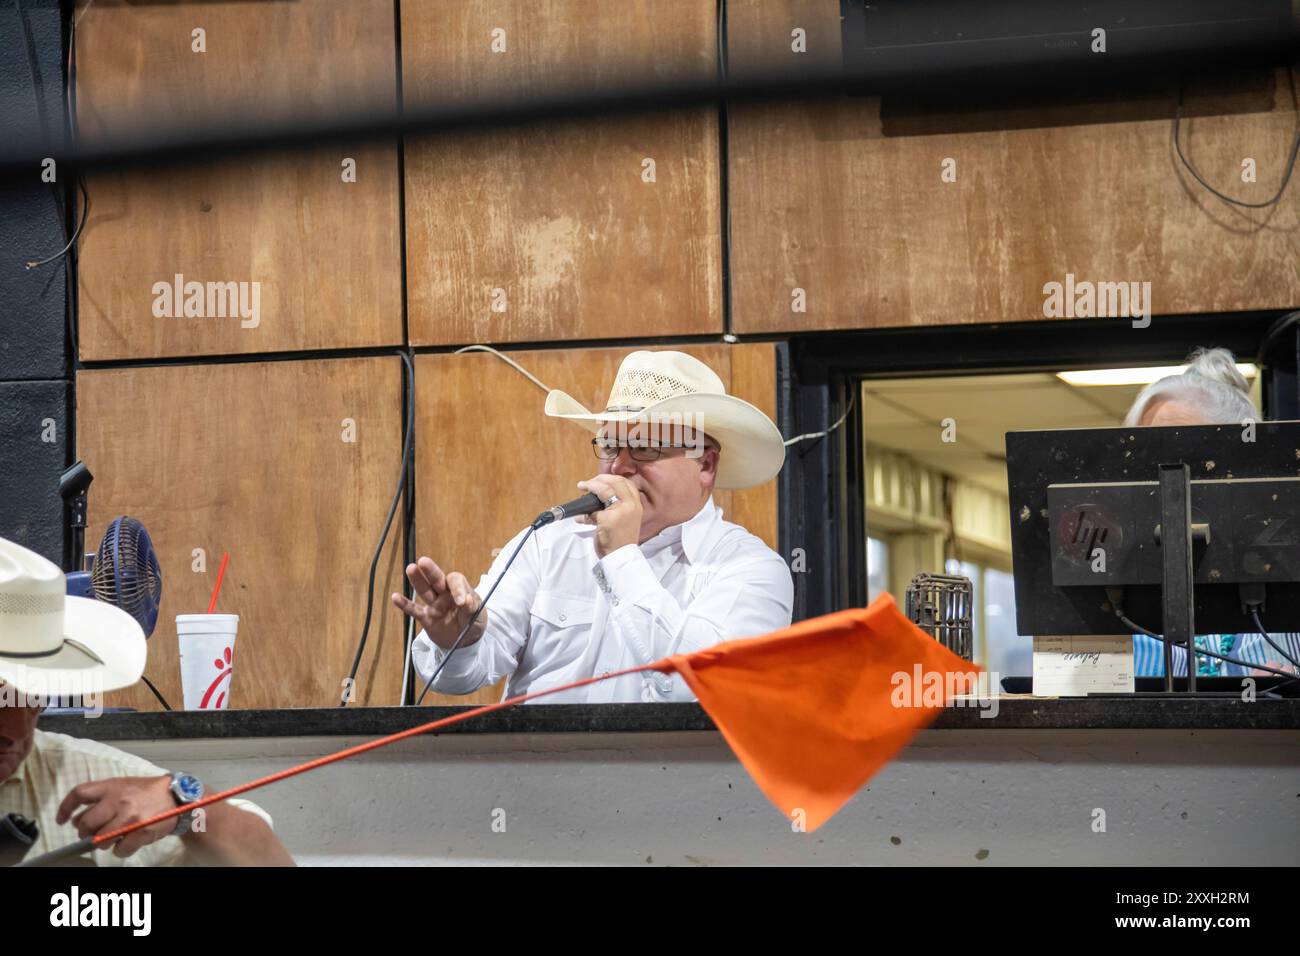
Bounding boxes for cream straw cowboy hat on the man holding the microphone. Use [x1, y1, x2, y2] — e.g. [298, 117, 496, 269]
[546, 351, 785, 488]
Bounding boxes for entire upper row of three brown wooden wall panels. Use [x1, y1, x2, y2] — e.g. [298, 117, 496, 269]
[78, 0, 1300, 360]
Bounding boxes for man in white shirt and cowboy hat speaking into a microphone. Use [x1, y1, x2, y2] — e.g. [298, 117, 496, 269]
[393, 351, 794, 702]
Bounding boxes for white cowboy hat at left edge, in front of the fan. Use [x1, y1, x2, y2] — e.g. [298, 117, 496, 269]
[0, 538, 144, 697]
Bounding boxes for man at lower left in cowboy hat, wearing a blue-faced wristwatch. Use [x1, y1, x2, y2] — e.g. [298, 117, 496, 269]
[0, 538, 293, 866]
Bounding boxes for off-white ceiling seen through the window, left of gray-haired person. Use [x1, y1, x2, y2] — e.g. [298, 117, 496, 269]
[862, 372, 1141, 494]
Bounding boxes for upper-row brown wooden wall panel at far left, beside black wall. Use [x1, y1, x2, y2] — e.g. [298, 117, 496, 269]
[77, 0, 403, 360]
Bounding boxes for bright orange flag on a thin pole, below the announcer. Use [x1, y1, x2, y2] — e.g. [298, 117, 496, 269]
[658, 594, 979, 832]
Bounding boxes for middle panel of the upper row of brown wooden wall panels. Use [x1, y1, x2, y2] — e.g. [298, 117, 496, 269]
[402, 0, 723, 346]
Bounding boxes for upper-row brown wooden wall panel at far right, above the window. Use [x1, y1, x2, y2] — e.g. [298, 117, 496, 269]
[728, 0, 1300, 334]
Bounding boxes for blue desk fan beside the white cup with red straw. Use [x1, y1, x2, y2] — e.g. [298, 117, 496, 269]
[58, 515, 172, 710]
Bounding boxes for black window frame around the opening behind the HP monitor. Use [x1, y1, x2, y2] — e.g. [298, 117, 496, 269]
[776, 310, 1300, 620]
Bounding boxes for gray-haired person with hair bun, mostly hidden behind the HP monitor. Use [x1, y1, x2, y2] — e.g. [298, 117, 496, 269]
[1125, 349, 1300, 676]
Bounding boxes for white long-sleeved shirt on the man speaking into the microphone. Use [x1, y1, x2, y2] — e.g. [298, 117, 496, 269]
[412, 498, 794, 704]
